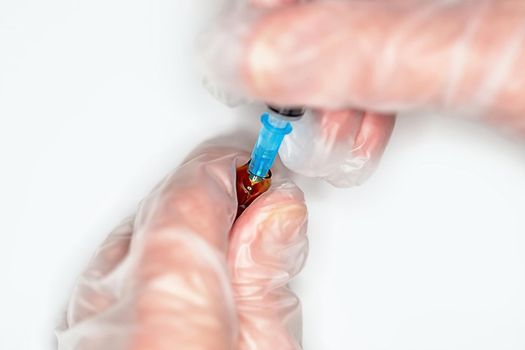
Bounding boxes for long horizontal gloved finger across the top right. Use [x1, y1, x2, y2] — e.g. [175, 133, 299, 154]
[242, 1, 525, 119]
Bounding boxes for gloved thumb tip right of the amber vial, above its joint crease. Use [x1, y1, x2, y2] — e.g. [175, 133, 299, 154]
[229, 181, 308, 284]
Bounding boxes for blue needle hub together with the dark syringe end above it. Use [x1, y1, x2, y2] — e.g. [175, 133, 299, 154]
[248, 106, 305, 183]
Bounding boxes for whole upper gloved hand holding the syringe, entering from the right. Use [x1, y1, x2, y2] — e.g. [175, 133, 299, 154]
[202, 0, 525, 185]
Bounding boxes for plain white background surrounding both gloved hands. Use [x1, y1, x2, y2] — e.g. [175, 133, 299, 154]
[0, 0, 525, 350]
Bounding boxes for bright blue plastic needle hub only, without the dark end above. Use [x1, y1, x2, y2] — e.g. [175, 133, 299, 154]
[248, 113, 292, 178]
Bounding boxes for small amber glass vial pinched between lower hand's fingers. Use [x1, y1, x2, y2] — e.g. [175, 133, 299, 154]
[237, 162, 272, 217]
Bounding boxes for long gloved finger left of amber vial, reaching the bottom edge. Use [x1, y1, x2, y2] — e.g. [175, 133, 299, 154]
[131, 149, 247, 349]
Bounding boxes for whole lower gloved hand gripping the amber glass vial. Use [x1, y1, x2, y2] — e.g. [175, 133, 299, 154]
[57, 148, 307, 350]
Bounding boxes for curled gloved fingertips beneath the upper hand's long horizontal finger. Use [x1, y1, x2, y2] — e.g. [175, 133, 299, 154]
[280, 109, 395, 187]
